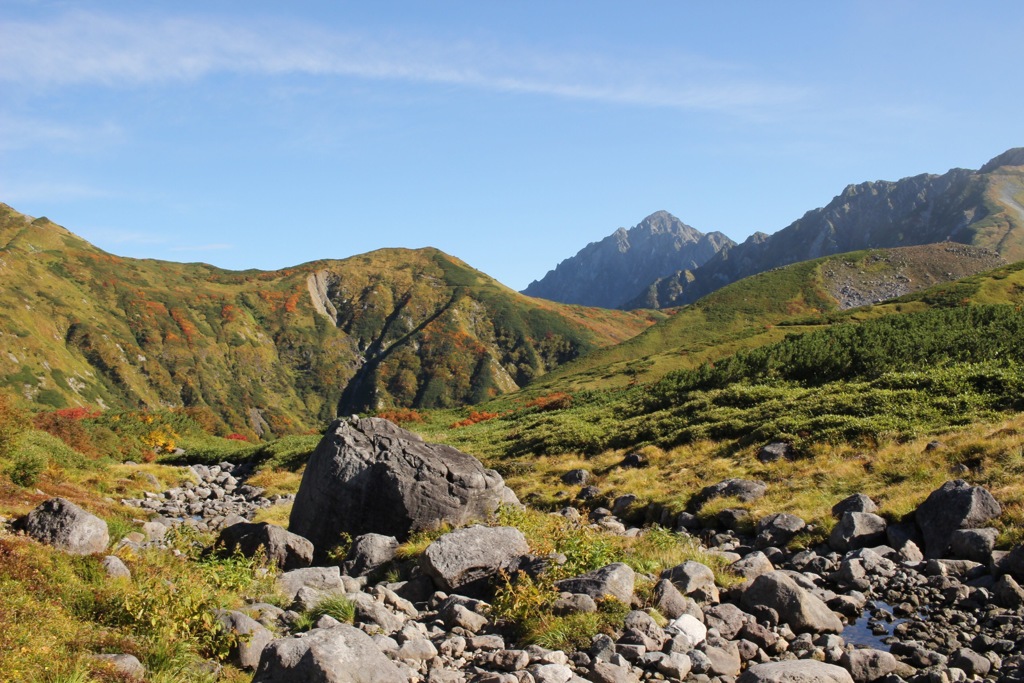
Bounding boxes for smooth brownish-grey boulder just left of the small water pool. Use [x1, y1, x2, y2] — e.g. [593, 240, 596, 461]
[740, 571, 843, 633]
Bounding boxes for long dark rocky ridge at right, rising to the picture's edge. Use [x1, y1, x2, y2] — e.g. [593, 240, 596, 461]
[626, 148, 1024, 307]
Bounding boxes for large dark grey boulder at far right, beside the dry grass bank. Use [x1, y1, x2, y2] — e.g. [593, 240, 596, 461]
[913, 479, 1002, 559]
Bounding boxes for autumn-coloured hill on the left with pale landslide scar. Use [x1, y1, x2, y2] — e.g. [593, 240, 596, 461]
[0, 204, 663, 435]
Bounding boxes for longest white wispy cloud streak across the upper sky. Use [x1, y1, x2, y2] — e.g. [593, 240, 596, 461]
[0, 12, 809, 111]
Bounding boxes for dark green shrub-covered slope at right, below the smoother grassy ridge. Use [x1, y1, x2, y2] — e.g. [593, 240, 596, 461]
[417, 257, 1024, 470]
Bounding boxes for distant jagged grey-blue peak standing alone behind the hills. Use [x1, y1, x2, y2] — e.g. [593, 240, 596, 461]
[522, 211, 735, 308]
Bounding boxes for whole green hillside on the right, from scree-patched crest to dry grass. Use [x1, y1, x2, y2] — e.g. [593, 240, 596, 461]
[420, 244, 1024, 504]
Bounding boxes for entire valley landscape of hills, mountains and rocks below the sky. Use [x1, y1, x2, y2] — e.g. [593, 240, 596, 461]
[0, 150, 1024, 683]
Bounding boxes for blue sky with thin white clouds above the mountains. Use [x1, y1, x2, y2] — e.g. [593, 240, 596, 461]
[0, 0, 1024, 289]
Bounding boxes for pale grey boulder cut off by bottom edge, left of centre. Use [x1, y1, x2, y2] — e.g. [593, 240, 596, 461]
[252, 625, 409, 683]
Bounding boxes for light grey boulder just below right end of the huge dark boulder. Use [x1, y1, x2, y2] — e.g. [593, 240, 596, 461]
[420, 526, 529, 595]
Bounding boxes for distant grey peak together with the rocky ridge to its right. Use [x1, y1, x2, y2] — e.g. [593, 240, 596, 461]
[523, 147, 1024, 309]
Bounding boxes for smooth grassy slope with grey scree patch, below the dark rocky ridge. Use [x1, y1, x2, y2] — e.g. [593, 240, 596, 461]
[527, 244, 1004, 395]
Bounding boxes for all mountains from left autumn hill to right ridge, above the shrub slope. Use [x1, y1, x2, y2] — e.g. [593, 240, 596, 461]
[0, 148, 1024, 436]
